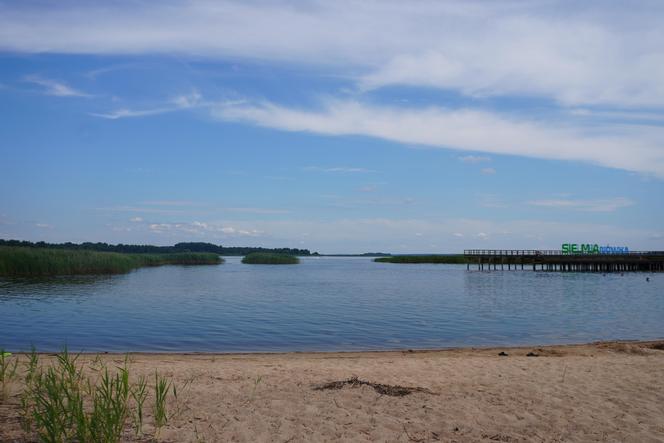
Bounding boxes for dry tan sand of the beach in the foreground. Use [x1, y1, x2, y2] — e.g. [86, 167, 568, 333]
[0, 341, 664, 442]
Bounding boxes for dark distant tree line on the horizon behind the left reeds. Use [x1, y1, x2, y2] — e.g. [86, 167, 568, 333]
[0, 239, 318, 256]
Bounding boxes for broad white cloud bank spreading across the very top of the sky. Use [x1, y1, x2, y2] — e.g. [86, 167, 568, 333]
[5, 0, 664, 107]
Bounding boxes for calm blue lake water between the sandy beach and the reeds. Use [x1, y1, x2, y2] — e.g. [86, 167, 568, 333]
[0, 257, 664, 352]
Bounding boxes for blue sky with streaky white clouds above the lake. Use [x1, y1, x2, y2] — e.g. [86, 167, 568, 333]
[0, 0, 664, 253]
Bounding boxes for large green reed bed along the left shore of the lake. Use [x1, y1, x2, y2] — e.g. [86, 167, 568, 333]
[0, 246, 223, 277]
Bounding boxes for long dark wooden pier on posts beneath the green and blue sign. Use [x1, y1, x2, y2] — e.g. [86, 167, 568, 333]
[463, 249, 664, 272]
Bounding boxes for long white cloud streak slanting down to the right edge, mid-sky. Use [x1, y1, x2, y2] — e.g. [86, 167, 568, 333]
[212, 100, 664, 177]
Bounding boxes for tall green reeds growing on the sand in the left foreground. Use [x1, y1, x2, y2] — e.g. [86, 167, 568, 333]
[0, 348, 174, 443]
